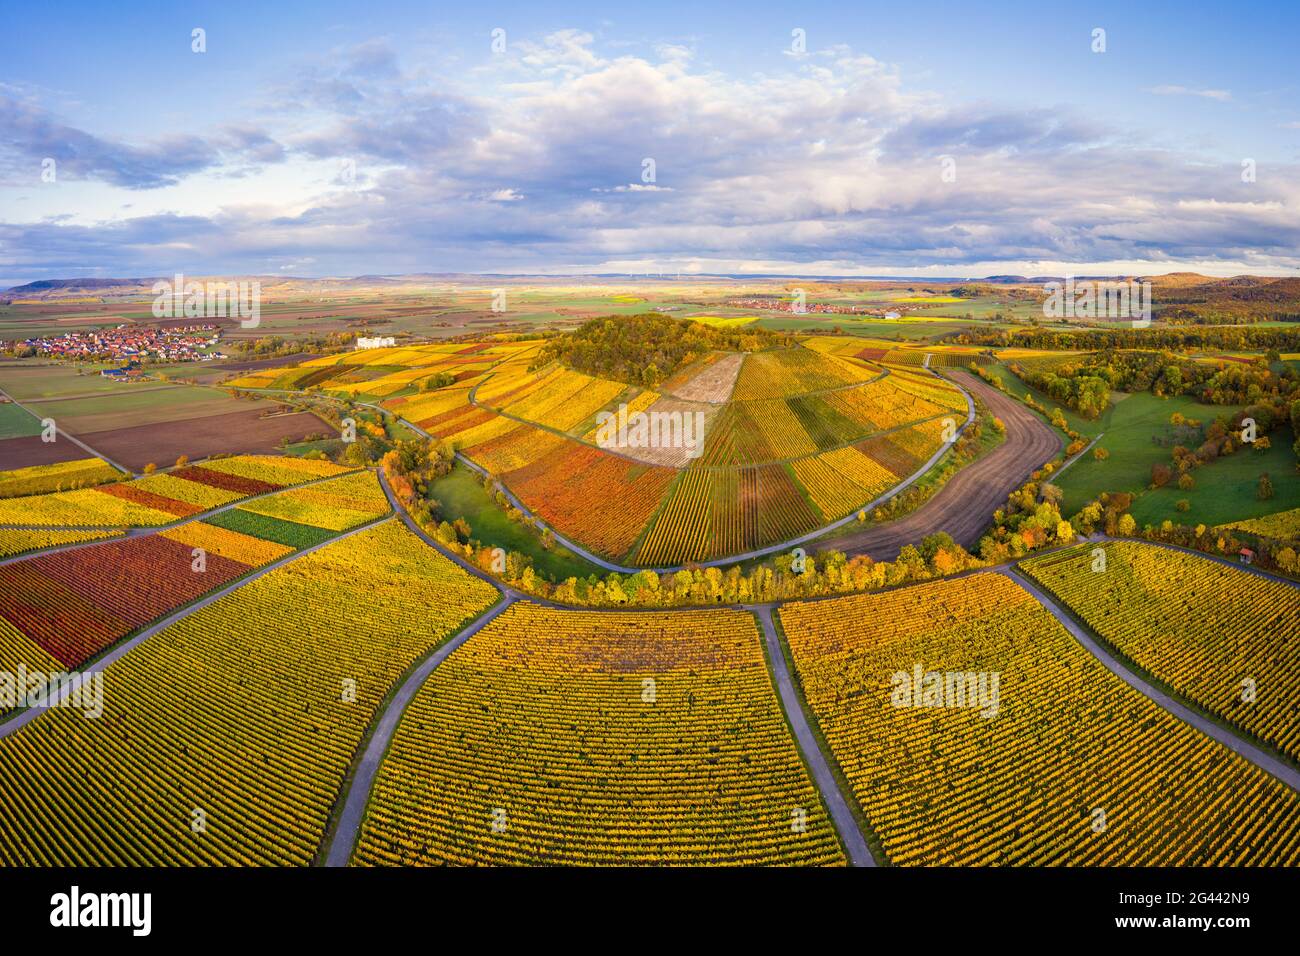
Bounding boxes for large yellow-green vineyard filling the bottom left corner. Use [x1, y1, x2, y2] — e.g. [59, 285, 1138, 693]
[0, 522, 497, 866]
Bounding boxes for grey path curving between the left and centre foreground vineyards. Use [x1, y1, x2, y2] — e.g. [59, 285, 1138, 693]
[325, 593, 515, 866]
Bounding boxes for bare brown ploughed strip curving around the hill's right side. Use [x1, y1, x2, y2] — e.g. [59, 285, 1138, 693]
[814, 372, 1061, 561]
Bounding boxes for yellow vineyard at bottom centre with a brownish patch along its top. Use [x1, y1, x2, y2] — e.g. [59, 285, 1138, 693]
[356, 604, 844, 865]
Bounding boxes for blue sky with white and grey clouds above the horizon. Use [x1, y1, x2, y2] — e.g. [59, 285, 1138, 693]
[0, 0, 1300, 285]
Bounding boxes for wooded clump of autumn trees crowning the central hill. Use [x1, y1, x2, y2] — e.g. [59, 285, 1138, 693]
[533, 312, 792, 388]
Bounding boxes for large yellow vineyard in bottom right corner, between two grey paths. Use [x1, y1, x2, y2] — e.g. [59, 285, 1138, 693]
[780, 574, 1300, 866]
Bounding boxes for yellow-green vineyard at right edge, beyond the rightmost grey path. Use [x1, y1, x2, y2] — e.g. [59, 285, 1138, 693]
[1023, 541, 1300, 760]
